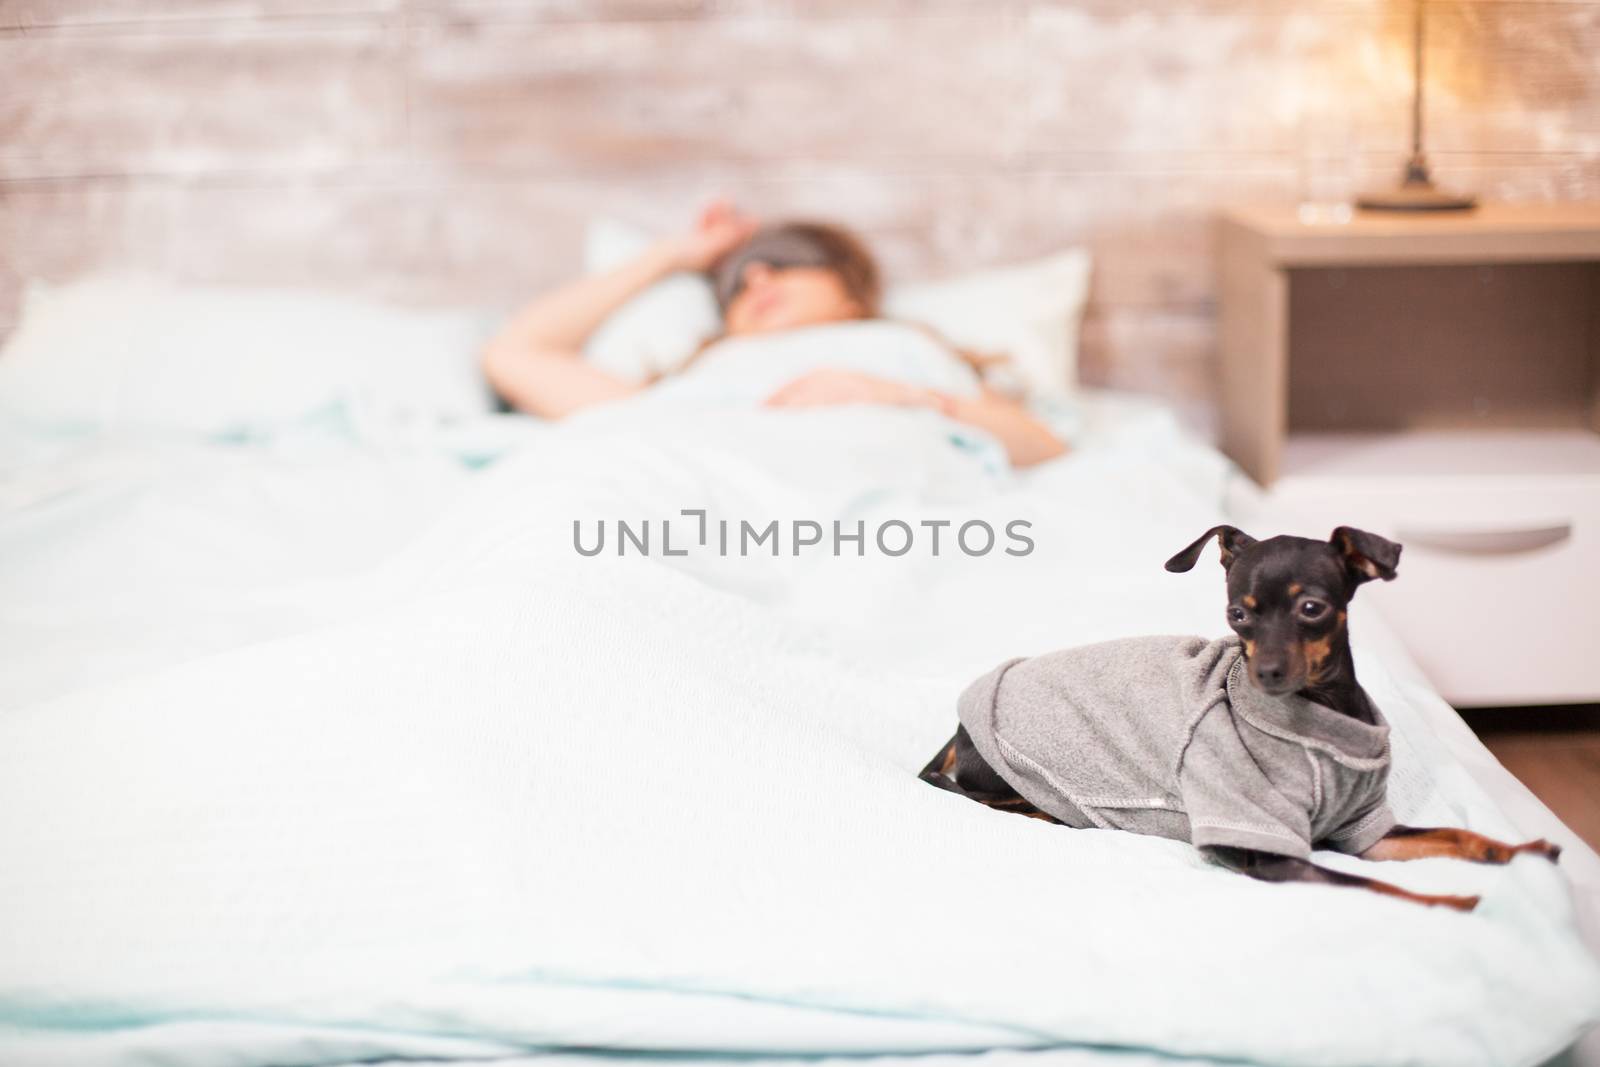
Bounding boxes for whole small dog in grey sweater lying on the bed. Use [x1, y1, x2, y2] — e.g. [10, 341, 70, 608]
[920, 526, 1560, 912]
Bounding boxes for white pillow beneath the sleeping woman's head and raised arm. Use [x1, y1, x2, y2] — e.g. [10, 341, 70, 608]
[584, 219, 1090, 394]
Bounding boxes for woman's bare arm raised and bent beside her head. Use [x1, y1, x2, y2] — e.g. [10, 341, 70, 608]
[483, 203, 757, 419]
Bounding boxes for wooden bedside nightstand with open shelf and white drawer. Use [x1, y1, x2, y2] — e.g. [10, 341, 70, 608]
[1219, 203, 1600, 705]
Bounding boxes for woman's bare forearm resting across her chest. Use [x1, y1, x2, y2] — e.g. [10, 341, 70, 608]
[766, 370, 1067, 467]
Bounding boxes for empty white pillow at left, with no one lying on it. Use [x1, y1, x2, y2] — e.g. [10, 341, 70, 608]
[0, 278, 493, 434]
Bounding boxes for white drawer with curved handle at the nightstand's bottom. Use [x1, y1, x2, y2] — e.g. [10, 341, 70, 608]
[1228, 435, 1600, 705]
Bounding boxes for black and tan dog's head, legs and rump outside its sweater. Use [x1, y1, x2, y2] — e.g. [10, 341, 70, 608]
[922, 526, 1560, 910]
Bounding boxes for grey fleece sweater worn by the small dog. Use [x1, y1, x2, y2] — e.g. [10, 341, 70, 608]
[958, 637, 1395, 857]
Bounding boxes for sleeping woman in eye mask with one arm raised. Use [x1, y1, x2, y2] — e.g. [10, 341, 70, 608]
[483, 203, 1066, 467]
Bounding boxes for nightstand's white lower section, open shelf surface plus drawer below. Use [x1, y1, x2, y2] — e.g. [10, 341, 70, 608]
[1230, 430, 1600, 707]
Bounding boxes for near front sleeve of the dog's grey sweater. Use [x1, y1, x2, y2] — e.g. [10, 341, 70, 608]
[1178, 709, 1310, 859]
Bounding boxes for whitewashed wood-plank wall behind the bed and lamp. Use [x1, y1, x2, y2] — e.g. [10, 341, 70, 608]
[0, 0, 1600, 419]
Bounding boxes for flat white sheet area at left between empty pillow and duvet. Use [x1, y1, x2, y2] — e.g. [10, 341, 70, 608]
[0, 416, 541, 710]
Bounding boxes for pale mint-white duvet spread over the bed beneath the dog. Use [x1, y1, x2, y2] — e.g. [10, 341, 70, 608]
[0, 379, 1600, 1067]
